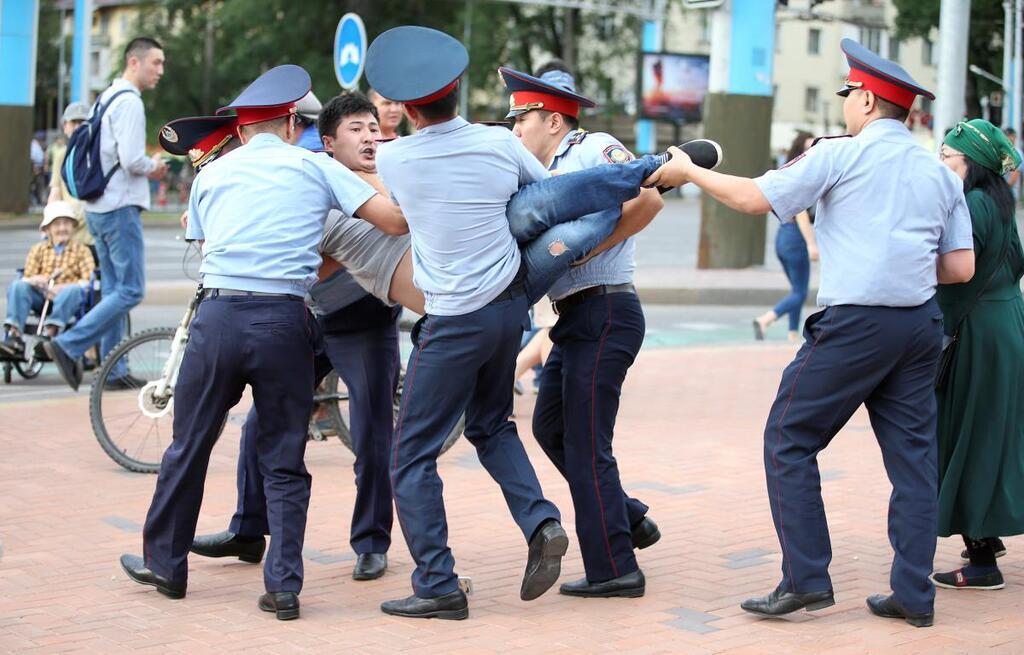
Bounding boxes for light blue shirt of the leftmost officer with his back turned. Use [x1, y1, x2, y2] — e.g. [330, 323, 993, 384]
[185, 133, 377, 296]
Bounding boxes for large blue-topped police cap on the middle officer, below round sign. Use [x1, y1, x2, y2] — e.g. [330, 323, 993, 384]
[366, 25, 469, 106]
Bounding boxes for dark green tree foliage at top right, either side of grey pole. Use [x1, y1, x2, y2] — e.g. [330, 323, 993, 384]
[893, 0, 1004, 120]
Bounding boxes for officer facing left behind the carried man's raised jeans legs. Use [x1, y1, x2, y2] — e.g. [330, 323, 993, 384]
[499, 61, 664, 598]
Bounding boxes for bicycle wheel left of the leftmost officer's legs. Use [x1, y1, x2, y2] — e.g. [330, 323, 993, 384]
[89, 328, 175, 473]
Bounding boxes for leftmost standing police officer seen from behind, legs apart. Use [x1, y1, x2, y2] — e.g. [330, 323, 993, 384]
[121, 66, 404, 619]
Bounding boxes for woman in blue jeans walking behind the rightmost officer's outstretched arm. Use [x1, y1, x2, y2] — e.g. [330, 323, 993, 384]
[754, 131, 818, 342]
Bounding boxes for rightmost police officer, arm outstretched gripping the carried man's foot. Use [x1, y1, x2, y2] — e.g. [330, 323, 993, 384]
[655, 39, 974, 626]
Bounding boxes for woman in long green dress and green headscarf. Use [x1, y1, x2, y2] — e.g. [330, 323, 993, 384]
[932, 120, 1024, 590]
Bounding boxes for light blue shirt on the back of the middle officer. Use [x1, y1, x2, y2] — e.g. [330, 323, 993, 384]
[377, 117, 548, 316]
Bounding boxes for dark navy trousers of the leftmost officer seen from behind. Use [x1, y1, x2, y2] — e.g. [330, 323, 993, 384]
[142, 296, 316, 592]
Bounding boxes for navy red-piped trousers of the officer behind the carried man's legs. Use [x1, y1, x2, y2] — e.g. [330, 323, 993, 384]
[534, 294, 647, 582]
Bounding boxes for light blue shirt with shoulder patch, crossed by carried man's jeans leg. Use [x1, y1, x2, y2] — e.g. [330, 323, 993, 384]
[548, 130, 636, 300]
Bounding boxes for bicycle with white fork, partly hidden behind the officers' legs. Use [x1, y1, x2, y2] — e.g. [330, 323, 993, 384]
[89, 285, 465, 473]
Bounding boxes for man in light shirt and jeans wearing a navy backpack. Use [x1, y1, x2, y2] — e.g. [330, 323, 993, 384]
[44, 37, 167, 391]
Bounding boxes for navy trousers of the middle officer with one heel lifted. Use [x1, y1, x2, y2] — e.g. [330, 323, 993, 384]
[391, 294, 559, 598]
